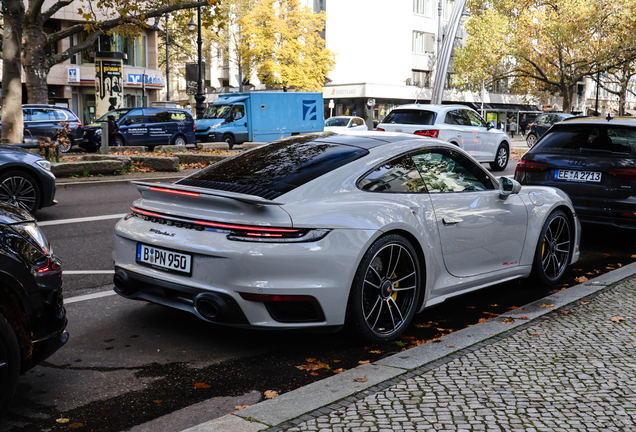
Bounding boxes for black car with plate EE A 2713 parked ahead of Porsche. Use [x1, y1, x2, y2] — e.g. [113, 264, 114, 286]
[515, 117, 636, 228]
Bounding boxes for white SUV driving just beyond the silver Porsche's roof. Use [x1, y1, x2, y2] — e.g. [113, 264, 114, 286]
[376, 104, 510, 171]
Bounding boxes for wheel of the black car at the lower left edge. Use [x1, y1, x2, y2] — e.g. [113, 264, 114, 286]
[0, 314, 20, 418]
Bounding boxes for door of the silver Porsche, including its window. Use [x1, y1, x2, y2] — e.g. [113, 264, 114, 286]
[413, 148, 528, 277]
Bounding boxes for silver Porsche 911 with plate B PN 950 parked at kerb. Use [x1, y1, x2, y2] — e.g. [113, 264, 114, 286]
[113, 132, 580, 342]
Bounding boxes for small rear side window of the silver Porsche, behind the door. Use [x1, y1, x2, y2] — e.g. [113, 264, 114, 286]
[358, 156, 426, 193]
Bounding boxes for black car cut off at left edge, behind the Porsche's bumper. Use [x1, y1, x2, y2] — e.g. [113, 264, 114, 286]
[0, 203, 68, 417]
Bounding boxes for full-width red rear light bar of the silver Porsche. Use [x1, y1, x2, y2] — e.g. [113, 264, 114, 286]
[130, 207, 331, 243]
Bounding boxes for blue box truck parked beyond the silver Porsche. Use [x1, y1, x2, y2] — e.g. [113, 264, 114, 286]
[195, 92, 325, 149]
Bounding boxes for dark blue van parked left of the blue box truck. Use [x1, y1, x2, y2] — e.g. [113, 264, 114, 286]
[82, 107, 196, 151]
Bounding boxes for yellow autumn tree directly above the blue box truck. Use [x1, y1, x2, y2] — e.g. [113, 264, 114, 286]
[240, 0, 335, 91]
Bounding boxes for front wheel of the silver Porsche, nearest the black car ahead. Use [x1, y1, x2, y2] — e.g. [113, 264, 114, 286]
[532, 210, 572, 285]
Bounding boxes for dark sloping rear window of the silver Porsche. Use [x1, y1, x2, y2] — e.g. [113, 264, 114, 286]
[177, 135, 368, 199]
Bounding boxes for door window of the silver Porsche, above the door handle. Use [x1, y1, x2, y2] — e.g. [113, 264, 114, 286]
[413, 149, 494, 193]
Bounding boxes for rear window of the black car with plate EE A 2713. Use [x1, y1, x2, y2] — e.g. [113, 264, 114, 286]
[531, 124, 636, 155]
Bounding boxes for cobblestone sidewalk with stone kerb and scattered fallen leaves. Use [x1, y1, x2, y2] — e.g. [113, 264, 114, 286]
[186, 263, 636, 432]
